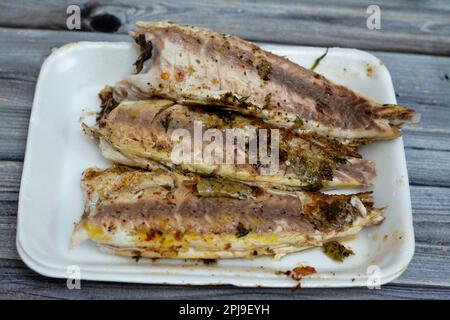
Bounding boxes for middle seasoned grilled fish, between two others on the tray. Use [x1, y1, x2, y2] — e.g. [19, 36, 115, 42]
[85, 94, 376, 190]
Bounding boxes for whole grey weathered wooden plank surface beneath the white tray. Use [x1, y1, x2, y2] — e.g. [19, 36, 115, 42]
[0, 0, 450, 300]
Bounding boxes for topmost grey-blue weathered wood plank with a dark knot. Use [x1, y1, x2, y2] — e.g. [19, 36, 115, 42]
[0, 0, 450, 55]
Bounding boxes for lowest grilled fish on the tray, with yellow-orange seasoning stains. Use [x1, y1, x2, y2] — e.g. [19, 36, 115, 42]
[72, 167, 383, 259]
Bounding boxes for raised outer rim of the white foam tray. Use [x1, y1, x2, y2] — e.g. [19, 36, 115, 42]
[16, 41, 415, 288]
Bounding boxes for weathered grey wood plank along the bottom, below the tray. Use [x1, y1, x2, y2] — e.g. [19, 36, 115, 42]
[0, 259, 450, 300]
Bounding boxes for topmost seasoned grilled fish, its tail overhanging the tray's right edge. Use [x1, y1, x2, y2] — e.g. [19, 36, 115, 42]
[116, 22, 415, 143]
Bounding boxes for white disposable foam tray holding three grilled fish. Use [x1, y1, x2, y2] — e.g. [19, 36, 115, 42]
[17, 42, 414, 287]
